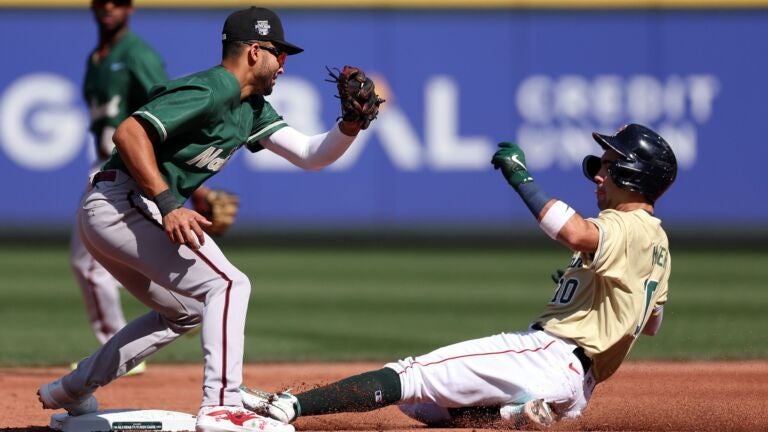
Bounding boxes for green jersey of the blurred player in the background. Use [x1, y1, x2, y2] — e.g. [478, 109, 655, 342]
[83, 31, 168, 160]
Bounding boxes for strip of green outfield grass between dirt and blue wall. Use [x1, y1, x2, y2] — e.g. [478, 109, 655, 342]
[0, 245, 768, 366]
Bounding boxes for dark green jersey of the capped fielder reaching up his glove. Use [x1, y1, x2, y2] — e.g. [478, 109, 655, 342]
[104, 66, 287, 203]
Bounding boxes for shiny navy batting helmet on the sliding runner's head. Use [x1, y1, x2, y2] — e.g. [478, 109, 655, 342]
[581, 124, 677, 203]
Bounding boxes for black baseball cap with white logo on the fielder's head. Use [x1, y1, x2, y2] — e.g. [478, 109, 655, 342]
[221, 6, 304, 55]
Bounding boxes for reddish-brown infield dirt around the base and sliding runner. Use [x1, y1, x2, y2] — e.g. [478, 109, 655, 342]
[0, 361, 768, 432]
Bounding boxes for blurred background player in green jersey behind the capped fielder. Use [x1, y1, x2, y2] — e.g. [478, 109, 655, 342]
[70, 0, 168, 374]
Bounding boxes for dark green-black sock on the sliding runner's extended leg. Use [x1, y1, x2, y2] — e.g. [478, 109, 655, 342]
[296, 368, 402, 415]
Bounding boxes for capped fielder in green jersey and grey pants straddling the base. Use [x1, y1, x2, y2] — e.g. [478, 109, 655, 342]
[38, 7, 380, 432]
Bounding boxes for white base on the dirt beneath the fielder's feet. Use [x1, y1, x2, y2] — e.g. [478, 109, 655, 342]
[50, 409, 196, 432]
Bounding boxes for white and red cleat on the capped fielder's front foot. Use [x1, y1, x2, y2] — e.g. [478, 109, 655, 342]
[195, 406, 295, 432]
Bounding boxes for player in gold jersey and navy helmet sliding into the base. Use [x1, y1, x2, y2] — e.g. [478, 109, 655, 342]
[241, 124, 677, 427]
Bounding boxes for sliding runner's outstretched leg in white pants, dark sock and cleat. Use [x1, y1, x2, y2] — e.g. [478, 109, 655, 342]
[243, 332, 575, 421]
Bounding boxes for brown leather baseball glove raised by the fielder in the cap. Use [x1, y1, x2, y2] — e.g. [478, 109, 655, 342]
[325, 66, 384, 129]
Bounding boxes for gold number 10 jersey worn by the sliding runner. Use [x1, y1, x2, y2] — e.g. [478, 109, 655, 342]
[536, 210, 672, 382]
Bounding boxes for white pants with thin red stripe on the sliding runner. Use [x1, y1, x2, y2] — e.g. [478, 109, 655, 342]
[386, 331, 594, 418]
